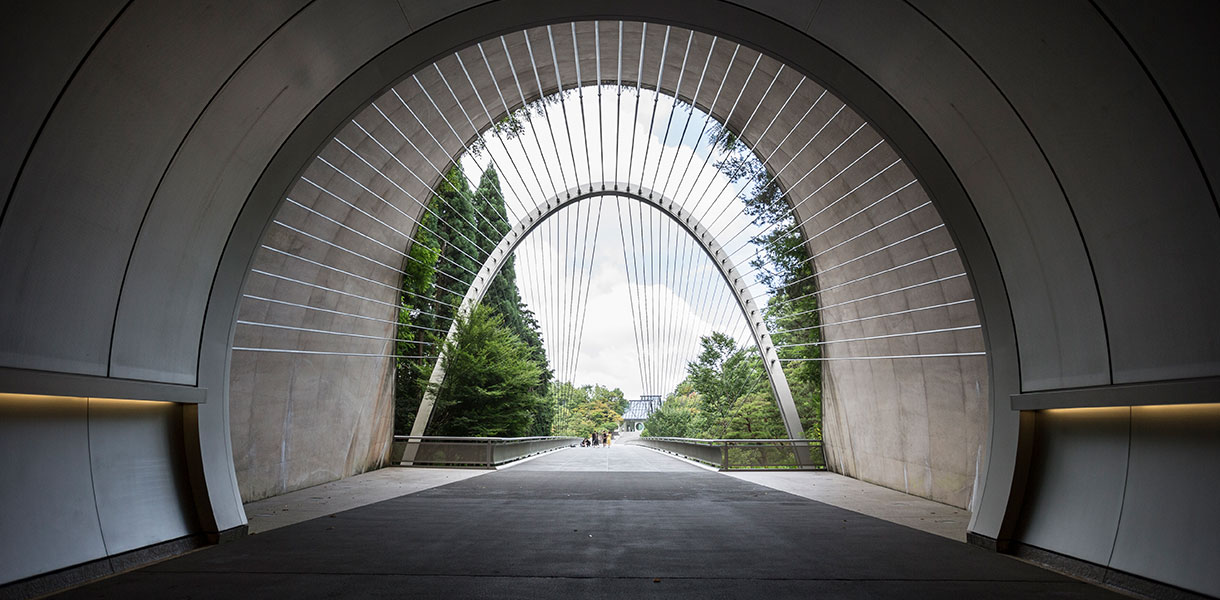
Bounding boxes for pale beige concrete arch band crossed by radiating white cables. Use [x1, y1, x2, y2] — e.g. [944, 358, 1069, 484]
[229, 21, 989, 507]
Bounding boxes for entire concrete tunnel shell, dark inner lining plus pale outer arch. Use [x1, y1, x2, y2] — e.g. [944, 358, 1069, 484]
[0, 0, 1220, 596]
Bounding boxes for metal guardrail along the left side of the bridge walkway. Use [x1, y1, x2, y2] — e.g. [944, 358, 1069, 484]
[390, 435, 581, 468]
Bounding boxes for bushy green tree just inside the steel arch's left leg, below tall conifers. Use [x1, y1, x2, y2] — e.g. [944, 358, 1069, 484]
[428, 305, 544, 437]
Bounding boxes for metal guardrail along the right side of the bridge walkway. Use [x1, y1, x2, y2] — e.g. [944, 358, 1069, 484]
[627, 438, 826, 471]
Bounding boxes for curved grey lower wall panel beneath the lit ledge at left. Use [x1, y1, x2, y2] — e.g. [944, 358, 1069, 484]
[0, 394, 200, 582]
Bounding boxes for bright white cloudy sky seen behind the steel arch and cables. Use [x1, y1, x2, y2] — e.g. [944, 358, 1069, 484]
[461, 82, 767, 398]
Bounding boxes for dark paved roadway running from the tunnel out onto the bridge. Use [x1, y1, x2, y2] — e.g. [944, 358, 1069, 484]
[54, 446, 1125, 600]
